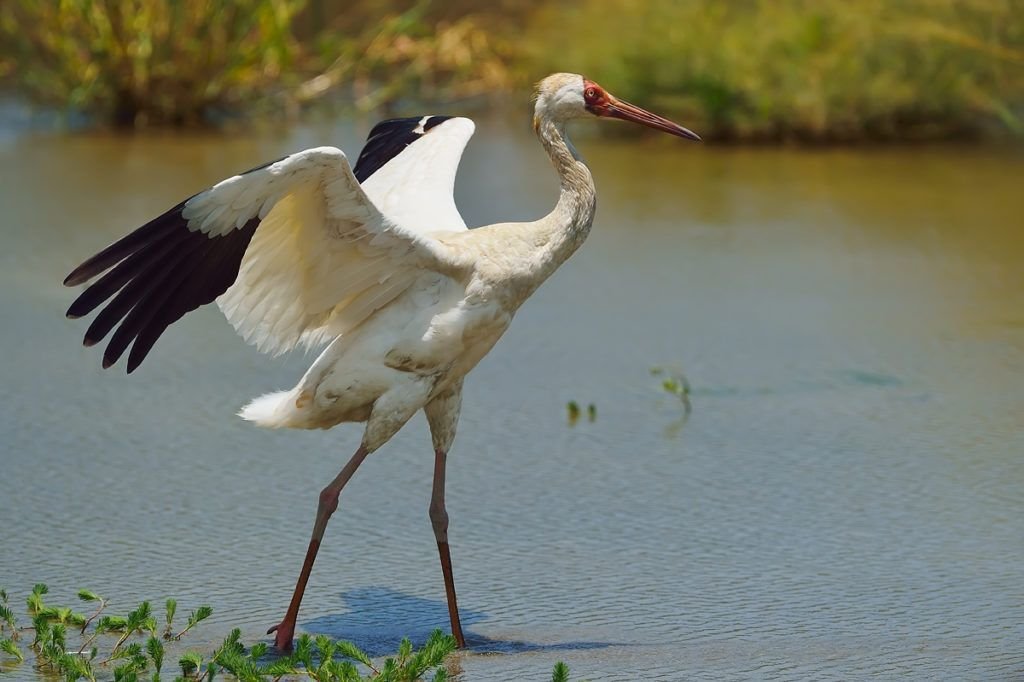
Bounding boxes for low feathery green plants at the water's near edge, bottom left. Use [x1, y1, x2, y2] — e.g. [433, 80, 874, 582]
[0, 584, 585, 682]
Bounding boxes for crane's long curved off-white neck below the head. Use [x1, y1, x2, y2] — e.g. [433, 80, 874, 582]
[532, 117, 597, 279]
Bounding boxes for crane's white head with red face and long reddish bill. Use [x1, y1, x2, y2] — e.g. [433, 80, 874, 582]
[534, 74, 700, 141]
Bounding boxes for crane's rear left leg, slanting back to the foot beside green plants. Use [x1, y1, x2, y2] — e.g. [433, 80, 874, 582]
[266, 380, 432, 651]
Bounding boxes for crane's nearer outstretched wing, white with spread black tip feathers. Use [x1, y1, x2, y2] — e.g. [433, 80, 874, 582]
[65, 142, 464, 372]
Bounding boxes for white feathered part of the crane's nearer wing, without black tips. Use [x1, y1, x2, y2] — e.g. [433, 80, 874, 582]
[182, 145, 462, 353]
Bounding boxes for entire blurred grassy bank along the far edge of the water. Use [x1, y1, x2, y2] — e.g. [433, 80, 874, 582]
[0, 0, 1024, 142]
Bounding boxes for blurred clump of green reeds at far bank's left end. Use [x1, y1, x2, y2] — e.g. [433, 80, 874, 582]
[0, 0, 303, 126]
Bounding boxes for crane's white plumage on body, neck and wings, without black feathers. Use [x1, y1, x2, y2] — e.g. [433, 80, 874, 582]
[194, 91, 594, 440]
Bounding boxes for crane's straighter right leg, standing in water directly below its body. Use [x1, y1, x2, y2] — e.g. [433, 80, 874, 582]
[424, 381, 466, 648]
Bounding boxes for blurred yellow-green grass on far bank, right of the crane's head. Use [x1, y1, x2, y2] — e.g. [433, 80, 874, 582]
[532, 0, 1024, 142]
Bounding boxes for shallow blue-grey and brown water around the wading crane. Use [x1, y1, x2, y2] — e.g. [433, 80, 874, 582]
[0, 121, 1024, 681]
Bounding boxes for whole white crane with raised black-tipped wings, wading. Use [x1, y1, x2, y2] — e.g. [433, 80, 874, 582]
[65, 74, 699, 650]
